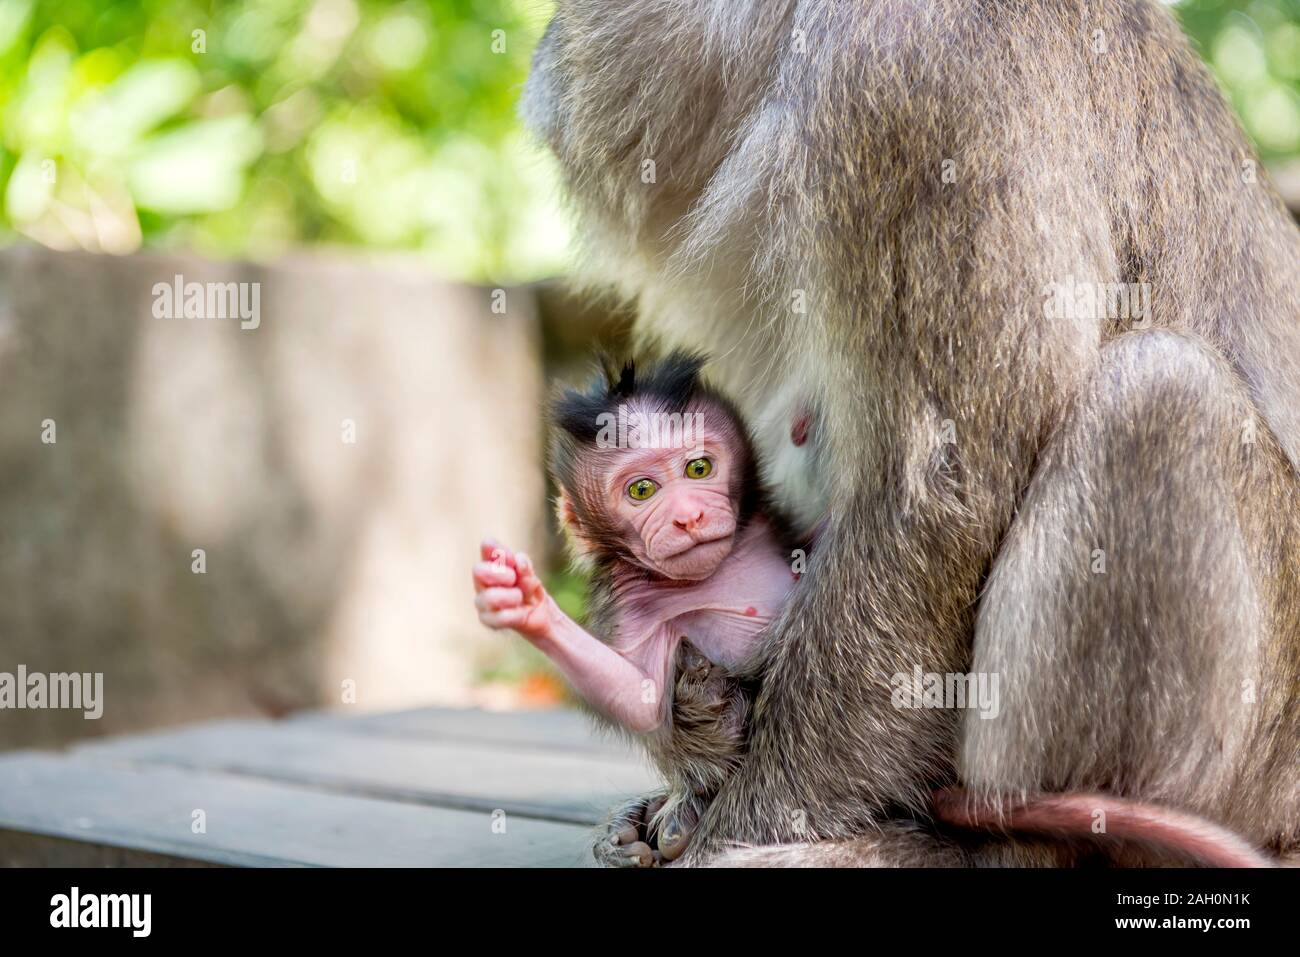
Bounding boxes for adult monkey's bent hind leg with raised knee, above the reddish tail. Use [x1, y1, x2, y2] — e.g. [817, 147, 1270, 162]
[961, 332, 1300, 849]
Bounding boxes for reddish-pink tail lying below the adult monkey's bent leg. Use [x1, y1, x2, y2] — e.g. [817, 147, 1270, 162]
[935, 788, 1273, 867]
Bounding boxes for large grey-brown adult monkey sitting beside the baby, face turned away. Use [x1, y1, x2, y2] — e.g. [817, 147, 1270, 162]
[525, 0, 1300, 863]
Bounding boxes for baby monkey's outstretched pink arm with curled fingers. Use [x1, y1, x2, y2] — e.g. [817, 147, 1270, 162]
[475, 541, 663, 733]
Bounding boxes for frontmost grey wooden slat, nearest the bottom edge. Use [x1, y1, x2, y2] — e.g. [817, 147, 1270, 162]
[0, 753, 592, 867]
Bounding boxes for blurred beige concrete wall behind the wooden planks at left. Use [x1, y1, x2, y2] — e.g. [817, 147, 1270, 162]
[0, 247, 545, 746]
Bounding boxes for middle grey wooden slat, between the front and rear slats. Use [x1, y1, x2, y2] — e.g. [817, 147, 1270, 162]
[73, 722, 655, 824]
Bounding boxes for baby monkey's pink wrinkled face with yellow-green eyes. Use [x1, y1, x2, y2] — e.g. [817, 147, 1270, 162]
[606, 433, 736, 581]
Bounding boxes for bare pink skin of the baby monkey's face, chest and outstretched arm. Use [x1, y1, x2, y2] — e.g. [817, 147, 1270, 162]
[473, 437, 796, 733]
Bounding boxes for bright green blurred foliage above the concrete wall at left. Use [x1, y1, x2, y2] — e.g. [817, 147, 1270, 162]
[0, 0, 567, 281]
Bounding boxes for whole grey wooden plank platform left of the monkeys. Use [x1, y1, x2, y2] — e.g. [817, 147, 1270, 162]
[0, 709, 655, 867]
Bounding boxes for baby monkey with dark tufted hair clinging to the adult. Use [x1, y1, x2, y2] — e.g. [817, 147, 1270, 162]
[475, 352, 798, 866]
